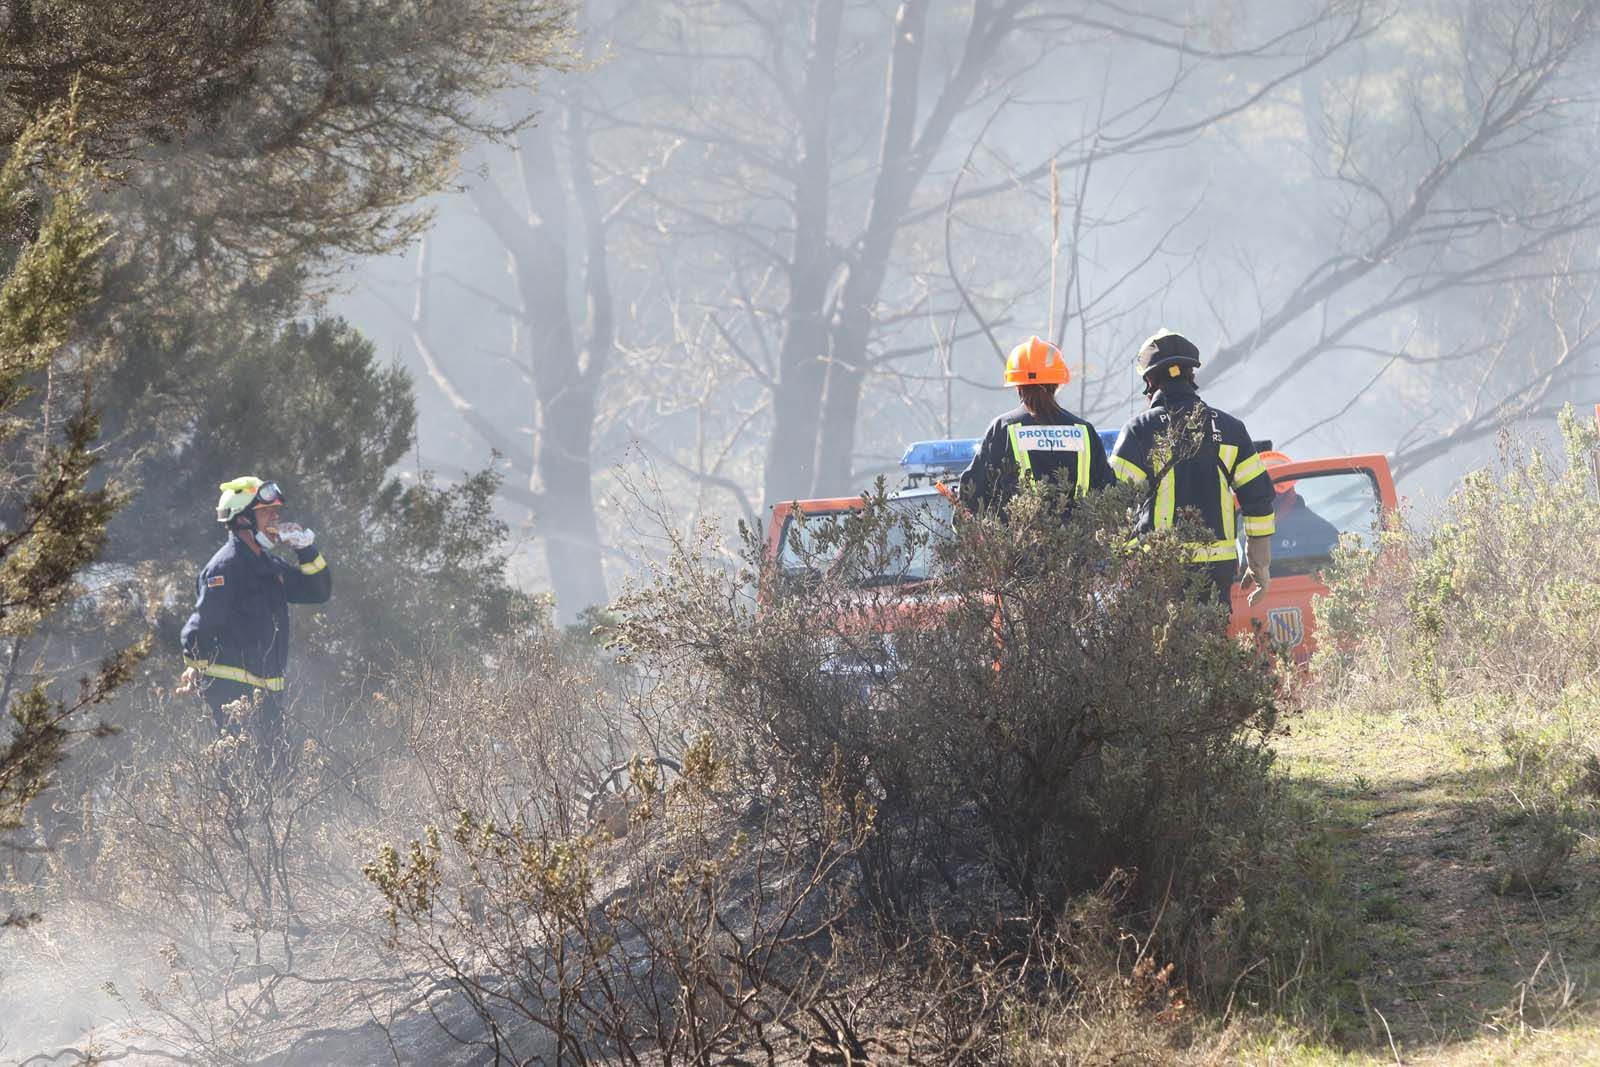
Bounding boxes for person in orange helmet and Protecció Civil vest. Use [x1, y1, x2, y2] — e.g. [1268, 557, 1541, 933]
[962, 338, 1117, 518]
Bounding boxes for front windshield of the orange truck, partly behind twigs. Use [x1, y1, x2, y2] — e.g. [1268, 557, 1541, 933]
[778, 493, 952, 589]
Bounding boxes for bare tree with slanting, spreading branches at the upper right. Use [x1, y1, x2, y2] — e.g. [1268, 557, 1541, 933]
[1210, 0, 1600, 470]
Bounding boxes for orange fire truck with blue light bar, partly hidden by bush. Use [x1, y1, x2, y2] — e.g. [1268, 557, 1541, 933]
[766, 432, 1398, 662]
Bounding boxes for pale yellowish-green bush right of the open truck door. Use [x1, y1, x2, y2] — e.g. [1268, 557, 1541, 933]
[1315, 410, 1600, 707]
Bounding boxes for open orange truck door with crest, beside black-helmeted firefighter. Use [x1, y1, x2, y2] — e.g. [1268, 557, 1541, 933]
[1229, 454, 1398, 662]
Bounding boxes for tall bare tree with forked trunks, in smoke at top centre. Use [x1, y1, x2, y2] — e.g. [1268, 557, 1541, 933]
[595, 0, 1370, 499]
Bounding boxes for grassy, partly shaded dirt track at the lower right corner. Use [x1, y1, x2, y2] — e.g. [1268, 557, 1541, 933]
[1240, 712, 1600, 1064]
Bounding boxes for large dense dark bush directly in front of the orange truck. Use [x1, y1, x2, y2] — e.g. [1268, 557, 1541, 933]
[619, 486, 1299, 998]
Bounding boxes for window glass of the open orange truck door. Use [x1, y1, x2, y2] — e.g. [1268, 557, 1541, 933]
[1272, 467, 1382, 577]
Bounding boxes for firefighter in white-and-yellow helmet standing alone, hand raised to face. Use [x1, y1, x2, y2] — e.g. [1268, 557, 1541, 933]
[179, 477, 333, 766]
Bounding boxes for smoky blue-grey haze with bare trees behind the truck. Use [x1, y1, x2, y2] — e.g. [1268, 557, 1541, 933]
[330, 0, 1600, 616]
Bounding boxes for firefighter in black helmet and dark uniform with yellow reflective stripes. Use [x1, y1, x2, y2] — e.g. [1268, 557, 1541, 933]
[1110, 330, 1274, 606]
